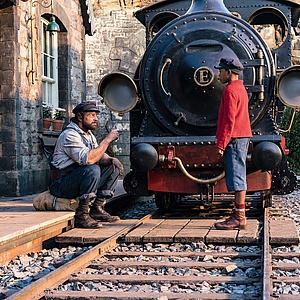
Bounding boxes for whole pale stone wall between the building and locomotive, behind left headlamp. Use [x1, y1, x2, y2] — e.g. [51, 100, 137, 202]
[86, 0, 157, 172]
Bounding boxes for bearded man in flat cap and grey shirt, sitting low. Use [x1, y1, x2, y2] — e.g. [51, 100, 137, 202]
[49, 102, 124, 228]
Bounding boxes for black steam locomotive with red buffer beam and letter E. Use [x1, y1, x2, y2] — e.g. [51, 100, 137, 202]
[98, 0, 300, 209]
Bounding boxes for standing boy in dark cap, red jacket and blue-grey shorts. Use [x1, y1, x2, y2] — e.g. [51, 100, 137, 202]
[215, 57, 252, 229]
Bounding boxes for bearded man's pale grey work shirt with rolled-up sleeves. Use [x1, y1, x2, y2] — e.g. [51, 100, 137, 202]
[52, 122, 98, 169]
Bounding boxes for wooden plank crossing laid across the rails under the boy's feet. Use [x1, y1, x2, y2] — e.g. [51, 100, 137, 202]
[56, 219, 299, 245]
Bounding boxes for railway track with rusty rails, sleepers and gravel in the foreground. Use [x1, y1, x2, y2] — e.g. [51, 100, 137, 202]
[7, 193, 300, 300]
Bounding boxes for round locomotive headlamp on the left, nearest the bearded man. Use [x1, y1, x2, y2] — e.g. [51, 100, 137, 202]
[98, 73, 138, 115]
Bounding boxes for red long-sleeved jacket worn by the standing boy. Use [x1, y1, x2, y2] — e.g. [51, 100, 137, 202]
[216, 80, 252, 150]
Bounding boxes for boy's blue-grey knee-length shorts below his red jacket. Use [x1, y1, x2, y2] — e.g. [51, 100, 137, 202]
[224, 138, 250, 192]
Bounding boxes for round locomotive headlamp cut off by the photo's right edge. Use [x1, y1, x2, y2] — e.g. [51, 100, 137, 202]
[276, 66, 300, 108]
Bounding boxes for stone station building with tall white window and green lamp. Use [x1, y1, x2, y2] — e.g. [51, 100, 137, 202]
[0, 0, 95, 196]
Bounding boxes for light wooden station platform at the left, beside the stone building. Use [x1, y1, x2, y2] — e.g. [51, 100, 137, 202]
[0, 180, 124, 265]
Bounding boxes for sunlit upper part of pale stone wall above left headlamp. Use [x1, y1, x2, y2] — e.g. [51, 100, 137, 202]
[86, 0, 158, 100]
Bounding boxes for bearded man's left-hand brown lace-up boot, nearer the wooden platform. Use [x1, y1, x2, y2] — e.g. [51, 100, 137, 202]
[75, 193, 102, 228]
